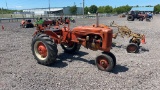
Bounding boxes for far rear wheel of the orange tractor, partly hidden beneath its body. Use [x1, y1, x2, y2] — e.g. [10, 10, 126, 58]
[61, 42, 81, 53]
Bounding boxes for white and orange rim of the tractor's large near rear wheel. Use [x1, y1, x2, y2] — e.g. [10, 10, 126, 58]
[34, 41, 48, 60]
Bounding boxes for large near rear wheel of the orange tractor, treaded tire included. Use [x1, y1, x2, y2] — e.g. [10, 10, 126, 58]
[31, 34, 58, 66]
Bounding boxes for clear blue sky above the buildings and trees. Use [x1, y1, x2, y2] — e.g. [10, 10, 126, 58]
[0, 0, 160, 9]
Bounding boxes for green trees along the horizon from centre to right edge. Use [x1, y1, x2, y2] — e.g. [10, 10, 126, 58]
[70, 4, 160, 14]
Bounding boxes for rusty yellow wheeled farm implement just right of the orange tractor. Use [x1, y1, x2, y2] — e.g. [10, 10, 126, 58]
[110, 21, 145, 53]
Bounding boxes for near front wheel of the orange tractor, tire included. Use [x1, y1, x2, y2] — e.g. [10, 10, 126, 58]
[95, 54, 115, 72]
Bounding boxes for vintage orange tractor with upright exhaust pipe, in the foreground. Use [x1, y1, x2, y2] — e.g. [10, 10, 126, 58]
[31, 13, 116, 71]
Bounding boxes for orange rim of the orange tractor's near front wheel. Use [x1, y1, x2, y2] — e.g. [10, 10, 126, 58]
[97, 56, 109, 70]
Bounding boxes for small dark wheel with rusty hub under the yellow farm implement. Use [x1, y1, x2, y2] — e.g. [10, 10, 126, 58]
[126, 43, 139, 53]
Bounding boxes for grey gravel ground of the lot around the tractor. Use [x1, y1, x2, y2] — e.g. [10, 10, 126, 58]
[0, 15, 160, 90]
